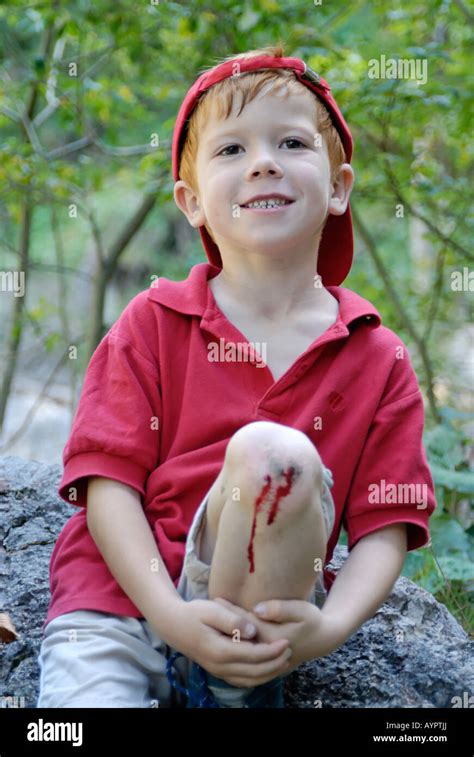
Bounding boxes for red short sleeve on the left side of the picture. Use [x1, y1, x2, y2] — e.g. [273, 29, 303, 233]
[58, 295, 161, 507]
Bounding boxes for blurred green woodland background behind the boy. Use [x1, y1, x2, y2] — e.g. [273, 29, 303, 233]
[0, 0, 474, 632]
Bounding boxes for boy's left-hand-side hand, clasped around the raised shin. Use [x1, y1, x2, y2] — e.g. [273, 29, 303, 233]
[173, 599, 289, 687]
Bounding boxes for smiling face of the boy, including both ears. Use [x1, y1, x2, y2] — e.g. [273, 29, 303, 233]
[175, 86, 353, 262]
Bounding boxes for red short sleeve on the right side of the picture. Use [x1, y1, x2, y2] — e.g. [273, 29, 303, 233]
[343, 348, 436, 551]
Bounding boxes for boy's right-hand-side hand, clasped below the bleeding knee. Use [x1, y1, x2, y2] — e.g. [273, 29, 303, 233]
[215, 597, 345, 675]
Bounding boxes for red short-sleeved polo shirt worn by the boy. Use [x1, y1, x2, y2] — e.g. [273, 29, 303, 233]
[44, 263, 436, 626]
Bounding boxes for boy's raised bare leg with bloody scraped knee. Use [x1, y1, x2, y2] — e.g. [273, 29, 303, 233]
[202, 421, 328, 610]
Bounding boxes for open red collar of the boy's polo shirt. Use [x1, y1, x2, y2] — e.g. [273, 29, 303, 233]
[148, 263, 382, 328]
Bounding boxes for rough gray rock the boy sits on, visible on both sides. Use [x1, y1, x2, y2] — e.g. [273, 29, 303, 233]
[0, 457, 474, 708]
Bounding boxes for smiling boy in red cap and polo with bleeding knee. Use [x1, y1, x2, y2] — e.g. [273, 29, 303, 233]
[38, 46, 435, 707]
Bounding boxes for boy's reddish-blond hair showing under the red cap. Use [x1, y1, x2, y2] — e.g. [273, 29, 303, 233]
[179, 42, 346, 239]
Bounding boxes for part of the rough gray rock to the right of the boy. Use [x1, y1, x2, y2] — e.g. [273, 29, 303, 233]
[286, 548, 474, 708]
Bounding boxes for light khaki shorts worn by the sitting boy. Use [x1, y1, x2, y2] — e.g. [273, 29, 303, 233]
[36, 468, 334, 708]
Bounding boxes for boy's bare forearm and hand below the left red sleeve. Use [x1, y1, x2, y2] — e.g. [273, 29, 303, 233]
[87, 476, 264, 660]
